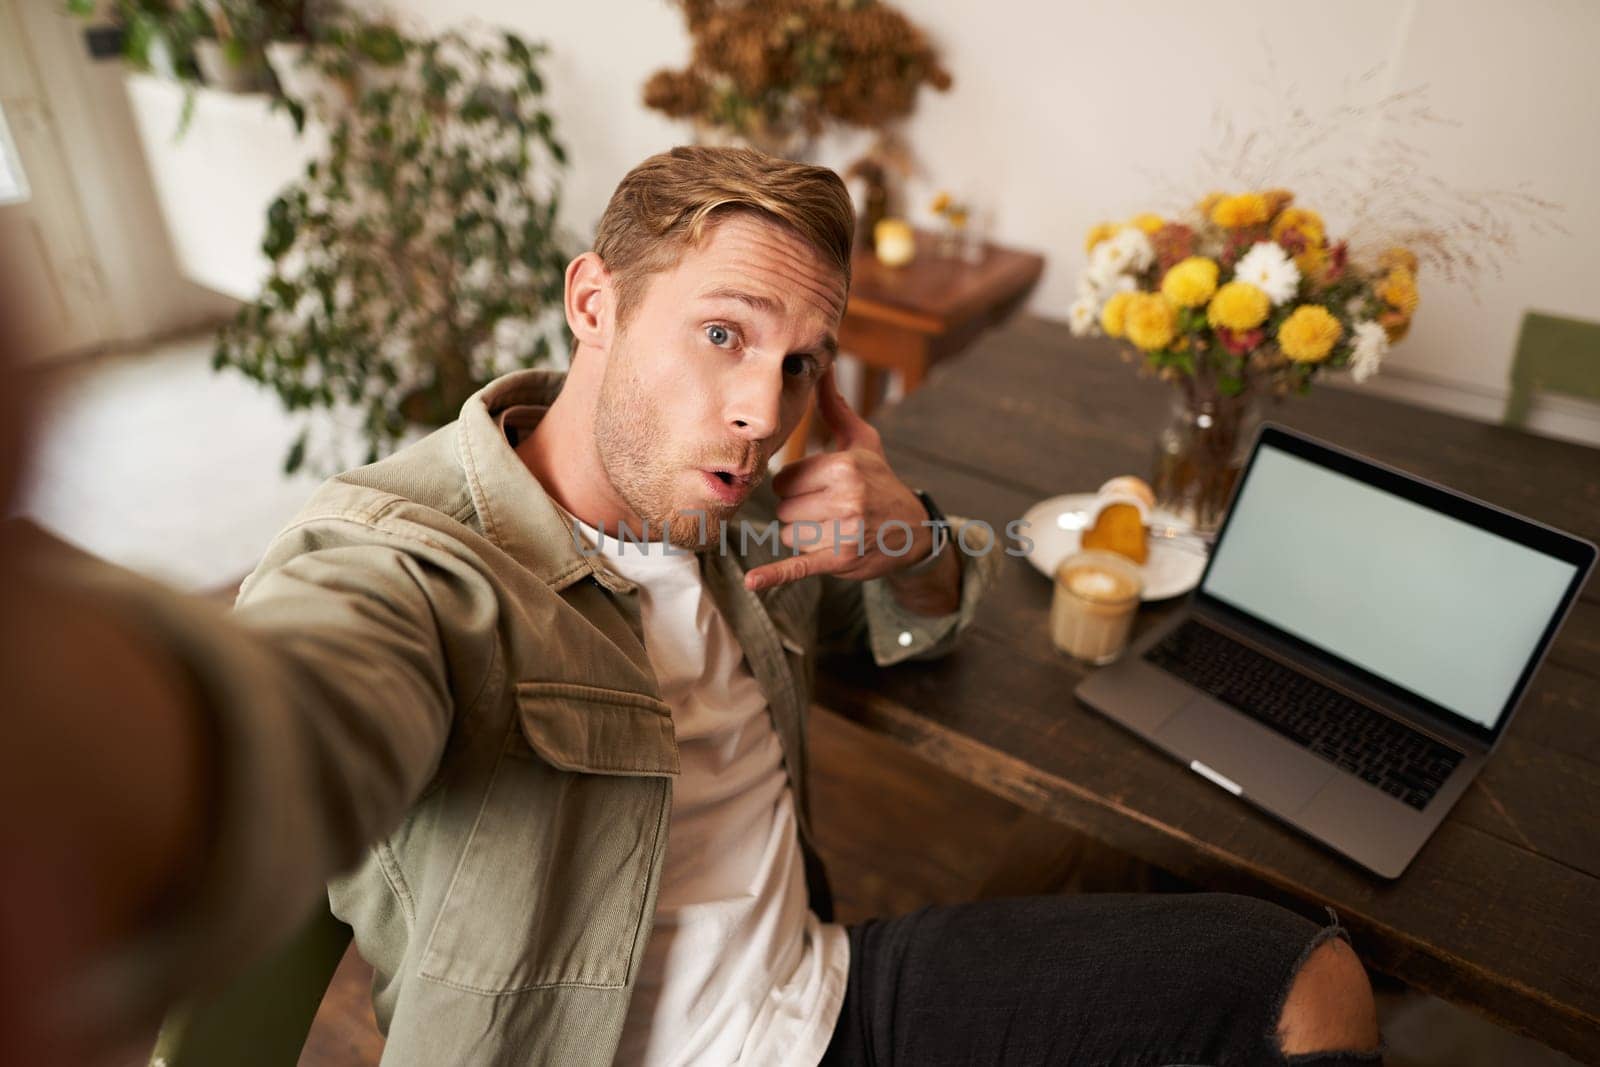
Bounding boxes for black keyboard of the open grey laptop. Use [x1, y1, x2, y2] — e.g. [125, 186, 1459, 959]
[1144, 619, 1461, 811]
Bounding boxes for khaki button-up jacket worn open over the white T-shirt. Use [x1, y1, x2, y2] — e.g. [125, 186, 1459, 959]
[90, 371, 998, 1067]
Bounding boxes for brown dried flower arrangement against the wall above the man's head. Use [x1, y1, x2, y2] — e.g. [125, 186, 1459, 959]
[645, 0, 950, 149]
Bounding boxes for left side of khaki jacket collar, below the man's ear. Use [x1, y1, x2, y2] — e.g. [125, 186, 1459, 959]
[456, 371, 635, 593]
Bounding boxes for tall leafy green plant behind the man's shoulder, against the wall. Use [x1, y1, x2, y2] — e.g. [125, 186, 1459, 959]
[213, 24, 574, 472]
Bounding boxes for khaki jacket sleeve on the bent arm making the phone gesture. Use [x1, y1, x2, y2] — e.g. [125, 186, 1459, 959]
[818, 515, 1000, 667]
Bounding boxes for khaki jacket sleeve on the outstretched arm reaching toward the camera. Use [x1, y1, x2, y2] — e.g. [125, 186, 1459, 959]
[59, 517, 498, 1030]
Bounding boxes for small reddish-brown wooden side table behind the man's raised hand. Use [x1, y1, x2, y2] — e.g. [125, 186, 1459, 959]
[784, 230, 1045, 462]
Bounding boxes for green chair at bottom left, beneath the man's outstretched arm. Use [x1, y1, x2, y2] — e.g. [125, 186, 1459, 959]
[150, 897, 350, 1067]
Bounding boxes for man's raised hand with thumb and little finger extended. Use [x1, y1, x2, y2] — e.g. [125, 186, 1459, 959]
[744, 366, 960, 614]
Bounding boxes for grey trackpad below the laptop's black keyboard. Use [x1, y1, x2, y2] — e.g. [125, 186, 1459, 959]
[1155, 696, 1338, 814]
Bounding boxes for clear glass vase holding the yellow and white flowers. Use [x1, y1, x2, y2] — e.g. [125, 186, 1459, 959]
[1150, 388, 1261, 537]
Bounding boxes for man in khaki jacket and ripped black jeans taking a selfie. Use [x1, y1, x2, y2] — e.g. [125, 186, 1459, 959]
[0, 149, 1378, 1067]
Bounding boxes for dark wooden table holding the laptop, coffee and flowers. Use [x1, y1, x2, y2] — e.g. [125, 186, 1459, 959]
[818, 320, 1600, 1061]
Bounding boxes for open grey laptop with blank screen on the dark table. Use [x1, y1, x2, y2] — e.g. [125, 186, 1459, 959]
[1077, 424, 1595, 878]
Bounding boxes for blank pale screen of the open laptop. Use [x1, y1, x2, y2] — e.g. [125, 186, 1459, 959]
[1203, 445, 1578, 729]
